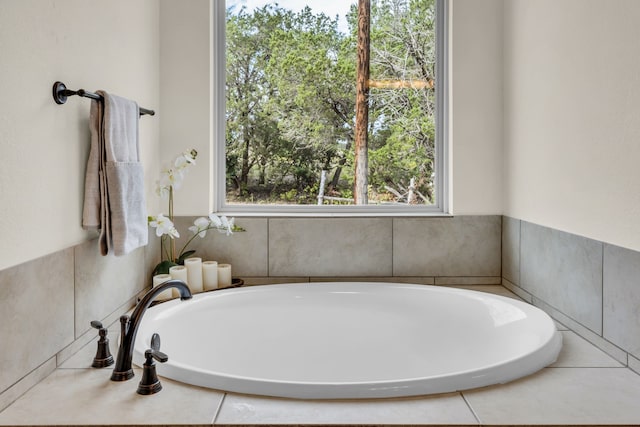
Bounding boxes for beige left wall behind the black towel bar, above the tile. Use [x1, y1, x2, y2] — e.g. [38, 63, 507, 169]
[0, 0, 163, 270]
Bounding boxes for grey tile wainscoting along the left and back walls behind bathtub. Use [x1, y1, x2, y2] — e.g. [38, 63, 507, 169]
[0, 215, 501, 410]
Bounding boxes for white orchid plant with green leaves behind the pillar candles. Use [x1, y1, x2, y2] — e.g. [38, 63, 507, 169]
[148, 149, 244, 275]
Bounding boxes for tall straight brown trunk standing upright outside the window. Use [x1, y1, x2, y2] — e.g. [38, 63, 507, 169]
[353, 0, 371, 205]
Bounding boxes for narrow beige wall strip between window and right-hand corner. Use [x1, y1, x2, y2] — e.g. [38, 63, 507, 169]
[450, 0, 503, 215]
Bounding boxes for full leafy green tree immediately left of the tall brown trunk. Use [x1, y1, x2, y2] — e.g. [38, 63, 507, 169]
[267, 7, 355, 195]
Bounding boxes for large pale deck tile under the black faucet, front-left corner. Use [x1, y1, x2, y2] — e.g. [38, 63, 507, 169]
[0, 368, 223, 425]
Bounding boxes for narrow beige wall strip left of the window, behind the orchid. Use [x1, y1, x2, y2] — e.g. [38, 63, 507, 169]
[160, 0, 215, 215]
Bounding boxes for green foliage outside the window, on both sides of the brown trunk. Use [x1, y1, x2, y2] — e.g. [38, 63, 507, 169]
[226, 0, 435, 204]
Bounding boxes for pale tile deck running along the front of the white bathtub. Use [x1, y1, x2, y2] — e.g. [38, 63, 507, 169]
[0, 285, 640, 425]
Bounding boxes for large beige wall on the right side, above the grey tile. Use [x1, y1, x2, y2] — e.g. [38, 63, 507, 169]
[504, 0, 640, 250]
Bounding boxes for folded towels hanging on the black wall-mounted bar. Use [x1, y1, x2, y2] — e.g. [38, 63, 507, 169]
[82, 91, 148, 256]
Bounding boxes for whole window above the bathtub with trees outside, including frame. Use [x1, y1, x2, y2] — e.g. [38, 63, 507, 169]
[214, 0, 448, 214]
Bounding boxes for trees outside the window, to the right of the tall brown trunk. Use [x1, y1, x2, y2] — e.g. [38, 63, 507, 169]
[369, 0, 436, 203]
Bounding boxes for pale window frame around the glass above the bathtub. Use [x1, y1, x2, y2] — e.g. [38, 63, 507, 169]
[211, 0, 451, 217]
